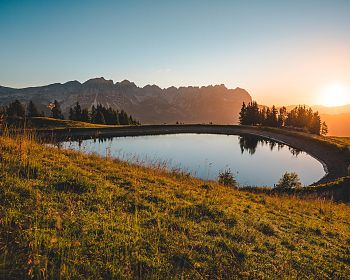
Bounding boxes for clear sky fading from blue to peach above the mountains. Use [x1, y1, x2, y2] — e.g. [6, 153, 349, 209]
[0, 0, 350, 105]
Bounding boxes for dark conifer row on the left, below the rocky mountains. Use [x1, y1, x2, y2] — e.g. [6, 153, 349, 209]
[0, 100, 140, 125]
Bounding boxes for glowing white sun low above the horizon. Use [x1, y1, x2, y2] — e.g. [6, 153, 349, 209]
[320, 84, 350, 107]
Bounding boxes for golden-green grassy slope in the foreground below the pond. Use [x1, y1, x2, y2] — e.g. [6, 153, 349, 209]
[0, 137, 350, 279]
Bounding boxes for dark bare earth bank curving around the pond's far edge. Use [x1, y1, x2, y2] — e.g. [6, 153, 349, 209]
[40, 125, 349, 184]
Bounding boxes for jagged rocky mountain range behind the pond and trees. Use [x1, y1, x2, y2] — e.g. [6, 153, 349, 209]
[0, 78, 251, 124]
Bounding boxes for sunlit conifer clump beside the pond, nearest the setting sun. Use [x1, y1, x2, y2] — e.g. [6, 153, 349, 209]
[239, 101, 328, 135]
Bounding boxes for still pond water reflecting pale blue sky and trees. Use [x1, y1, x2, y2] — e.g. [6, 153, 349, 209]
[61, 134, 325, 186]
